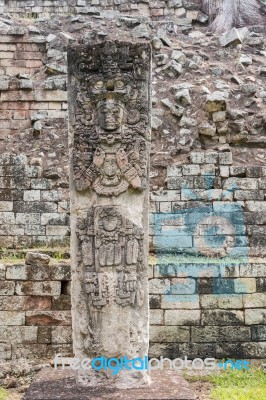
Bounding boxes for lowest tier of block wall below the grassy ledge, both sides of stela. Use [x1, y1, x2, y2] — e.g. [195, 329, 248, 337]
[0, 253, 266, 361]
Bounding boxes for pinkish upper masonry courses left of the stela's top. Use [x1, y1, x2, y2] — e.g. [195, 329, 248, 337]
[0, 26, 67, 134]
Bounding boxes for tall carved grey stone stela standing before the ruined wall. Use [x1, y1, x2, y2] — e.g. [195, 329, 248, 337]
[68, 41, 151, 387]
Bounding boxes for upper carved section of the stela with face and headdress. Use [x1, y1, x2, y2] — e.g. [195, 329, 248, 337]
[67, 42, 150, 196]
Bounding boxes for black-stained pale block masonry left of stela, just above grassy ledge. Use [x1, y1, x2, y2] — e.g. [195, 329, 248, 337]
[0, 153, 69, 249]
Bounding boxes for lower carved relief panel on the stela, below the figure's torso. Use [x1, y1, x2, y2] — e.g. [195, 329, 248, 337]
[77, 207, 144, 307]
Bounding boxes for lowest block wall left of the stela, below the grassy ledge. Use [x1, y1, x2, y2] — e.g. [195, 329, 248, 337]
[0, 253, 72, 360]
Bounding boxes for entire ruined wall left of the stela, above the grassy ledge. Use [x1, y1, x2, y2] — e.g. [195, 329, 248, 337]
[0, 26, 69, 248]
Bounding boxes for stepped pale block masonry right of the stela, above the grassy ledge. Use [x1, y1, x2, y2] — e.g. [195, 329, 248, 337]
[151, 151, 266, 257]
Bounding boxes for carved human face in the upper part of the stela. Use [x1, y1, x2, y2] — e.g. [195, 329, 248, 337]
[97, 100, 124, 132]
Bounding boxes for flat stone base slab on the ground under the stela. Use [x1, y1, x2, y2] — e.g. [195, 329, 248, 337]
[23, 368, 196, 400]
